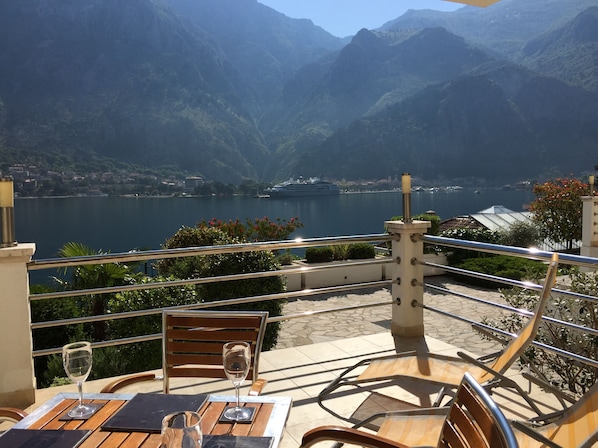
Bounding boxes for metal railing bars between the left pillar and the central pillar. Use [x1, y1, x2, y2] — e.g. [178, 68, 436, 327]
[27, 234, 392, 357]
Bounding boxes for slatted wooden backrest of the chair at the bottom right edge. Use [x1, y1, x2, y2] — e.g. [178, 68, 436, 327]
[438, 373, 518, 448]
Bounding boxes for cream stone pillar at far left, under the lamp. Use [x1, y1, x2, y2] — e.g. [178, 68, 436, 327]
[0, 243, 35, 408]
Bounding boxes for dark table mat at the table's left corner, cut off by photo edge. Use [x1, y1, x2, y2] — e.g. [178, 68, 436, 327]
[0, 428, 91, 448]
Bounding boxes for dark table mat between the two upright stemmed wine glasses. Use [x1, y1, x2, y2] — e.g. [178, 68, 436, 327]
[102, 394, 208, 433]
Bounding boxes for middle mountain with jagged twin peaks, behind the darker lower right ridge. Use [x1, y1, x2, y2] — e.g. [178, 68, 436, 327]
[261, 28, 492, 177]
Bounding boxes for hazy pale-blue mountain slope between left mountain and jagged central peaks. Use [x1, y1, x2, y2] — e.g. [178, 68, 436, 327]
[168, 0, 345, 117]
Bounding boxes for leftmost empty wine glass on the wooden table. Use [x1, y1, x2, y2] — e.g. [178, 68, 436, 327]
[62, 342, 97, 418]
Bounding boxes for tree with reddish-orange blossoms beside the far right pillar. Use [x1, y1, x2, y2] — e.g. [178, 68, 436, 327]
[530, 179, 589, 250]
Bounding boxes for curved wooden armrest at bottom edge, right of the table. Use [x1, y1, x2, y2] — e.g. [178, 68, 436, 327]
[301, 426, 409, 448]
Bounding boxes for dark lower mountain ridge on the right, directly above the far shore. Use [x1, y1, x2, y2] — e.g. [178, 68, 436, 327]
[293, 63, 598, 183]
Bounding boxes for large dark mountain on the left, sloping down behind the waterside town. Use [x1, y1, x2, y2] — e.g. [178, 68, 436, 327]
[0, 0, 268, 180]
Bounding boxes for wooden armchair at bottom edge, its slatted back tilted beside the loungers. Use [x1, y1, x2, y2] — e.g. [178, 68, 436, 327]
[301, 373, 518, 448]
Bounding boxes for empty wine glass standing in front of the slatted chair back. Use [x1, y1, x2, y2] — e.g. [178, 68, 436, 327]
[222, 341, 251, 421]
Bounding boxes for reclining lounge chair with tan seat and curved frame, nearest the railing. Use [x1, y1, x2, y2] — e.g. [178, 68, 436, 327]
[318, 253, 558, 422]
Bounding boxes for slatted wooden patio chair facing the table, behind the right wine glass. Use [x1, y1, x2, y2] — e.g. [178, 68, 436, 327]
[101, 310, 268, 395]
